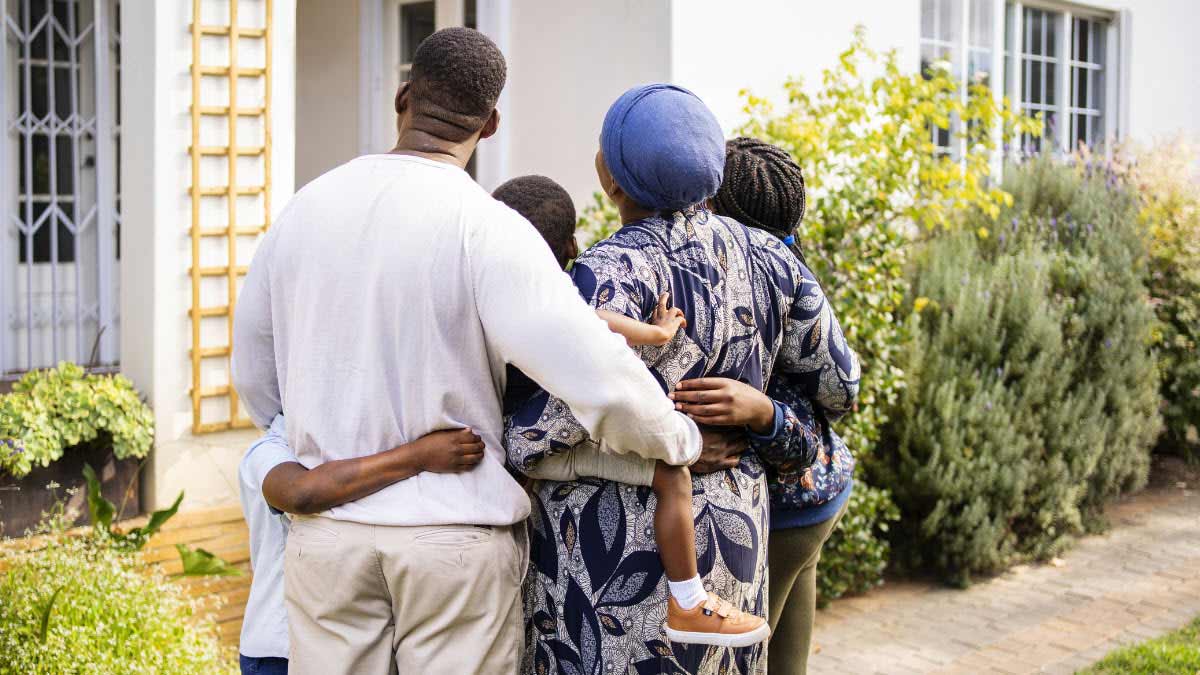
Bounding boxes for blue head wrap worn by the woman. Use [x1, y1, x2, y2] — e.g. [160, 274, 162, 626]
[600, 84, 725, 211]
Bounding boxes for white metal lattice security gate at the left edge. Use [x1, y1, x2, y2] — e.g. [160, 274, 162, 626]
[0, 0, 120, 378]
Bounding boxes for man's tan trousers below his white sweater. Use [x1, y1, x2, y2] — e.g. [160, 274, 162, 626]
[284, 516, 528, 675]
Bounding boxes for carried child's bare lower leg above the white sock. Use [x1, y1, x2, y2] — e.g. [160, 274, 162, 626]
[650, 461, 700, 581]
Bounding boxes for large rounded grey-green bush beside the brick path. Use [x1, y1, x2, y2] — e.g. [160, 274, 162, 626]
[871, 160, 1159, 583]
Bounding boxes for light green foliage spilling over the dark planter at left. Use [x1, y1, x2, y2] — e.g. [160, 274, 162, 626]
[0, 363, 154, 478]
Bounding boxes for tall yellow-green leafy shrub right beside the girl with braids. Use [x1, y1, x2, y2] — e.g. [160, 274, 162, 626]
[739, 28, 1042, 598]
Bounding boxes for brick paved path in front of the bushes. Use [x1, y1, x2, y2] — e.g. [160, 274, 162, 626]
[809, 484, 1200, 675]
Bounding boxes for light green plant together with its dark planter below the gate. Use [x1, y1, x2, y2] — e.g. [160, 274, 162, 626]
[0, 363, 154, 536]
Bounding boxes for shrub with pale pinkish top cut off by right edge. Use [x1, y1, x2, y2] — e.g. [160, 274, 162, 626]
[1128, 138, 1200, 462]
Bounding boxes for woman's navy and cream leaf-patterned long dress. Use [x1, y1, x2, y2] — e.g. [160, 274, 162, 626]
[505, 209, 858, 675]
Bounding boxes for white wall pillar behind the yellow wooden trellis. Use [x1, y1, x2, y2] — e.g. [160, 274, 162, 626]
[120, 0, 296, 508]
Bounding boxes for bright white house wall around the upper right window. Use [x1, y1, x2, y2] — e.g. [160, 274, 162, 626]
[671, 0, 1200, 142]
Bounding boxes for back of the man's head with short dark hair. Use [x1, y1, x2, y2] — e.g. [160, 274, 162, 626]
[409, 28, 508, 141]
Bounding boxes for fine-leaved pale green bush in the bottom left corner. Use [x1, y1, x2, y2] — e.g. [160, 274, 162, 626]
[0, 531, 235, 675]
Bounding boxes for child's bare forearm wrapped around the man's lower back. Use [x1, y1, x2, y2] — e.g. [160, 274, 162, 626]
[263, 429, 484, 514]
